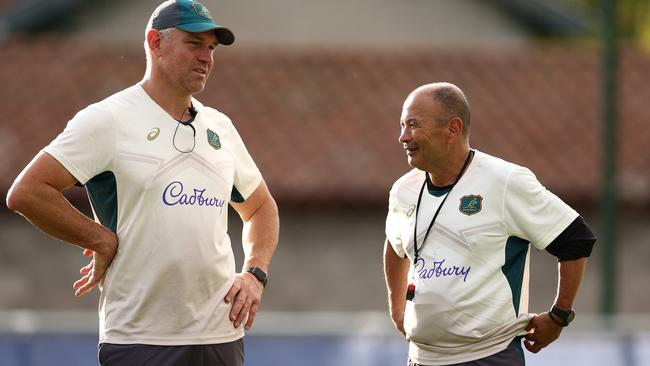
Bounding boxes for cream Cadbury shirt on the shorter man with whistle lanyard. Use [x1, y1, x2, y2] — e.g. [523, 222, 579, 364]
[386, 151, 578, 365]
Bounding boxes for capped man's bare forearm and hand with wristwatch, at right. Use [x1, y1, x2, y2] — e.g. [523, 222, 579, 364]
[224, 180, 280, 330]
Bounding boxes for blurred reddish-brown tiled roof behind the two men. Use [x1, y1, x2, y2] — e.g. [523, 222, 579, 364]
[0, 37, 650, 209]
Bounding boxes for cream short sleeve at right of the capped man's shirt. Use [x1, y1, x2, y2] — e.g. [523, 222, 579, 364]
[225, 123, 262, 202]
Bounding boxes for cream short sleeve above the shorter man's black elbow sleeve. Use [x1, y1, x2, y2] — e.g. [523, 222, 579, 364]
[504, 167, 578, 250]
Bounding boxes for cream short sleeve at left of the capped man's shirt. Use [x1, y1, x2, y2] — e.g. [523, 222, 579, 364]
[43, 104, 115, 184]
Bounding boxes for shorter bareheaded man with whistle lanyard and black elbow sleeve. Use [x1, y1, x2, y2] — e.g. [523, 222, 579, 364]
[384, 83, 596, 366]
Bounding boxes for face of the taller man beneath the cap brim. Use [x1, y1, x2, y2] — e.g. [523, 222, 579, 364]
[157, 28, 218, 96]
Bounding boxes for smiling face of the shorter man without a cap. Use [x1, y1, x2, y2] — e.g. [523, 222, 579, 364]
[399, 91, 449, 171]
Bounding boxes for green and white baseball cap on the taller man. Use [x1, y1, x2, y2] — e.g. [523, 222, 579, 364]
[149, 0, 235, 46]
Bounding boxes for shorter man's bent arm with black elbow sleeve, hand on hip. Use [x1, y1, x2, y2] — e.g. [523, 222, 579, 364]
[524, 217, 596, 353]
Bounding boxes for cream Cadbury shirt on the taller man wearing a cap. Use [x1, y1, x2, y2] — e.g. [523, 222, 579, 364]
[44, 85, 262, 345]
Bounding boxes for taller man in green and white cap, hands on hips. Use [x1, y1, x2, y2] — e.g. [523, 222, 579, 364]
[7, 0, 279, 366]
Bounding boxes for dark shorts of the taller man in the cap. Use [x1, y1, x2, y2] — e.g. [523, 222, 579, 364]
[99, 338, 244, 366]
